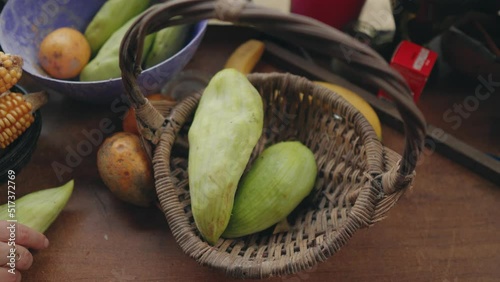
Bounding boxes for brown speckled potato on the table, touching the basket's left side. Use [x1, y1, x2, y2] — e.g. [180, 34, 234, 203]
[97, 132, 155, 206]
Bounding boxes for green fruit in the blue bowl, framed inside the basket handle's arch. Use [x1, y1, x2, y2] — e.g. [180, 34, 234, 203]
[145, 24, 190, 68]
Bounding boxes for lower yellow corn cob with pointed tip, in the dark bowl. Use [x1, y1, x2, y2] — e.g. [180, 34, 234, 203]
[0, 92, 47, 149]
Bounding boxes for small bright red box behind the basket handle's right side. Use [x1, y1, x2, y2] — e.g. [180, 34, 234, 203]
[378, 41, 437, 103]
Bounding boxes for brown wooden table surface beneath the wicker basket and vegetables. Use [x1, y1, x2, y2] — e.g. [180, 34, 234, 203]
[0, 27, 500, 282]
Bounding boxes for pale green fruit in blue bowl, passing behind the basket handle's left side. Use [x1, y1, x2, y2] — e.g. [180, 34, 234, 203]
[80, 17, 156, 81]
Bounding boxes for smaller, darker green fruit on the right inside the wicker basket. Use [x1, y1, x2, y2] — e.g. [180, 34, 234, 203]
[222, 141, 317, 238]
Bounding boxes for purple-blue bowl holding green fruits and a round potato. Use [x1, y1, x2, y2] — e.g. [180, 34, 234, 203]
[0, 0, 207, 104]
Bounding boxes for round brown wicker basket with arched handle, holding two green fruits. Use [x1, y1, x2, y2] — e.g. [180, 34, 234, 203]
[120, 0, 425, 278]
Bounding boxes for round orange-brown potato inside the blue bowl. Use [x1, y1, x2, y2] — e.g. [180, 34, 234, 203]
[38, 27, 91, 79]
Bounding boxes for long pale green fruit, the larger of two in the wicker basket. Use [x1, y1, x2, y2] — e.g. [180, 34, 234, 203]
[188, 69, 264, 244]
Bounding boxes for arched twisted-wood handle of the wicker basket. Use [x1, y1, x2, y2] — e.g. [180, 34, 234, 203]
[120, 0, 426, 193]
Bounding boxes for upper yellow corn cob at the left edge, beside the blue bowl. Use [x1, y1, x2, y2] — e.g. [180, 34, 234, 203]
[0, 52, 23, 93]
